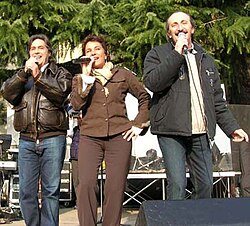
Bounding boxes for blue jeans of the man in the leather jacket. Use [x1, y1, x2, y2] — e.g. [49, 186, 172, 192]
[18, 135, 66, 226]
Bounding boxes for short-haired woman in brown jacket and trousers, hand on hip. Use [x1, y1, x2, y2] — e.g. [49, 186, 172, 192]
[71, 35, 150, 226]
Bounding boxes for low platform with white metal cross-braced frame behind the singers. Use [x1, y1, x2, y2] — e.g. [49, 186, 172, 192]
[98, 171, 241, 206]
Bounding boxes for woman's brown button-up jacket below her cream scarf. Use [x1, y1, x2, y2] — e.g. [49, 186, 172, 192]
[70, 68, 150, 137]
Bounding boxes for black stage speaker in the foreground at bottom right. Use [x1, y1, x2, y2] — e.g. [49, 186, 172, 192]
[135, 198, 250, 226]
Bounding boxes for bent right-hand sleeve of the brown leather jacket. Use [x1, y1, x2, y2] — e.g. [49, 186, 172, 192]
[35, 67, 72, 107]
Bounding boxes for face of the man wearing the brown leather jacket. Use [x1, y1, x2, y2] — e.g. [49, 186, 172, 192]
[29, 39, 51, 67]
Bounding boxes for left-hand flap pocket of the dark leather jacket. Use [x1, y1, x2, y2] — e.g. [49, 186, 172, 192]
[13, 102, 28, 132]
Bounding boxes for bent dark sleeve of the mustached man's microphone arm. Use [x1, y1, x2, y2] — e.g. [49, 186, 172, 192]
[143, 46, 185, 93]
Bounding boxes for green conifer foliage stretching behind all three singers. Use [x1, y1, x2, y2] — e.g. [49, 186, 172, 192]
[0, 0, 250, 101]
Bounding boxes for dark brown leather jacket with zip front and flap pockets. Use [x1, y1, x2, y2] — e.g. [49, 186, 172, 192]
[1, 62, 72, 140]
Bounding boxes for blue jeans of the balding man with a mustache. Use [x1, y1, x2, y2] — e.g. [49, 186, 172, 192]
[158, 134, 213, 200]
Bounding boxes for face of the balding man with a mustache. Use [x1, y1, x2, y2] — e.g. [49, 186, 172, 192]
[167, 12, 195, 44]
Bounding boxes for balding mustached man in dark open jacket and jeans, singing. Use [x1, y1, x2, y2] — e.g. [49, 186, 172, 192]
[144, 12, 248, 200]
